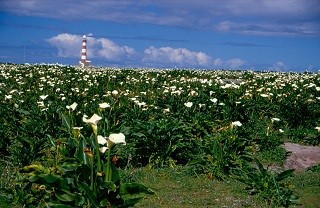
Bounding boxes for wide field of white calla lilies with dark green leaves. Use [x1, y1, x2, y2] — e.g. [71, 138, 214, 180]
[0, 64, 320, 207]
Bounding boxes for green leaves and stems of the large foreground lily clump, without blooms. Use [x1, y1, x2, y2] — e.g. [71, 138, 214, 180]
[7, 115, 153, 207]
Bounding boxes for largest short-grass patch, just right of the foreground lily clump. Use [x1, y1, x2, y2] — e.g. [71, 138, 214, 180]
[121, 167, 268, 208]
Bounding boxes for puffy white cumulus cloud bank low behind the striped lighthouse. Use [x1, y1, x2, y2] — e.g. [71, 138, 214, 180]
[47, 33, 245, 69]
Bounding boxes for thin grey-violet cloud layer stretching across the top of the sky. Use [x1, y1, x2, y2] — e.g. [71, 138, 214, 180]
[0, 0, 320, 36]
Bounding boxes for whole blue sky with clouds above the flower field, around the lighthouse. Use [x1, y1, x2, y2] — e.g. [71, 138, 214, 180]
[0, 0, 320, 71]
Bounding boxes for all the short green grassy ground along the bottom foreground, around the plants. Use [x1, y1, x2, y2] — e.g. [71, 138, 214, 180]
[0, 162, 320, 208]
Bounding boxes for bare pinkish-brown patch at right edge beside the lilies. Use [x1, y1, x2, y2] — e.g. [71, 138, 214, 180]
[284, 143, 320, 172]
